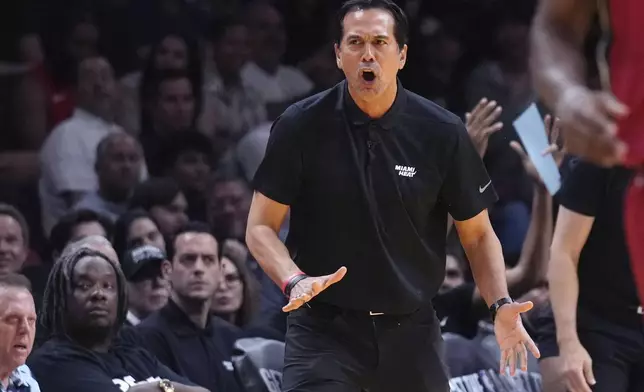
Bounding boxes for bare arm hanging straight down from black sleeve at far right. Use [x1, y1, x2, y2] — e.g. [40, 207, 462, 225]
[548, 206, 594, 343]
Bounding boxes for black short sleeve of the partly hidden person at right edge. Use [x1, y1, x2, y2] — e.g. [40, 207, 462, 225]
[557, 158, 610, 216]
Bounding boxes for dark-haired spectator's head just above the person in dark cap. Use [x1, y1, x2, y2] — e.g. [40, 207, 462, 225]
[113, 209, 166, 255]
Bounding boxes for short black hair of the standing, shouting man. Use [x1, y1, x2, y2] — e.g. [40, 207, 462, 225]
[335, 0, 409, 49]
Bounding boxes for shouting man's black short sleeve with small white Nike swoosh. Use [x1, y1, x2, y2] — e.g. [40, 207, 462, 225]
[441, 124, 498, 221]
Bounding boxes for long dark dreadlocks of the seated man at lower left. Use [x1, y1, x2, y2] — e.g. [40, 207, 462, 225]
[41, 247, 127, 339]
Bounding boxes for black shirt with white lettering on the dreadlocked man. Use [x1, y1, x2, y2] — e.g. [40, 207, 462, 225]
[27, 338, 194, 392]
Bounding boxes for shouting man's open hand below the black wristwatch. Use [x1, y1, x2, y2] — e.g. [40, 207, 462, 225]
[494, 301, 541, 376]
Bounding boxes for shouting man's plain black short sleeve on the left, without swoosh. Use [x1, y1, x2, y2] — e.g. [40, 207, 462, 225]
[253, 105, 305, 205]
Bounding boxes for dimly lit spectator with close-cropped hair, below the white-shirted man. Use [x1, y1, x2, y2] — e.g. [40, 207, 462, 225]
[74, 132, 144, 221]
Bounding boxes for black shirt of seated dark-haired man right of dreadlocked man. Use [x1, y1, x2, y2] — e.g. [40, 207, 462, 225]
[135, 300, 241, 392]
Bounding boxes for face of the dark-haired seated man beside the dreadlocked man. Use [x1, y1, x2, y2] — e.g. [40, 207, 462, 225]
[164, 233, 221, 302]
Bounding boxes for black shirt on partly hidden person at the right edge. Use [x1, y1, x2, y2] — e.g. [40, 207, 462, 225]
[558, 159, 641, 325]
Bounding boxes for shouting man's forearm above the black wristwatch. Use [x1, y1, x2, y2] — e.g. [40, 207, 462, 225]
[463, 229, 508, 306]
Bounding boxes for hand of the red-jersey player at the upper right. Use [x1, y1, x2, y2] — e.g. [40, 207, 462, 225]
[556, 87, 629, 166]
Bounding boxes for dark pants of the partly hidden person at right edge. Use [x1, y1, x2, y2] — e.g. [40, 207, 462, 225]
[537, 308, 644, 392]
